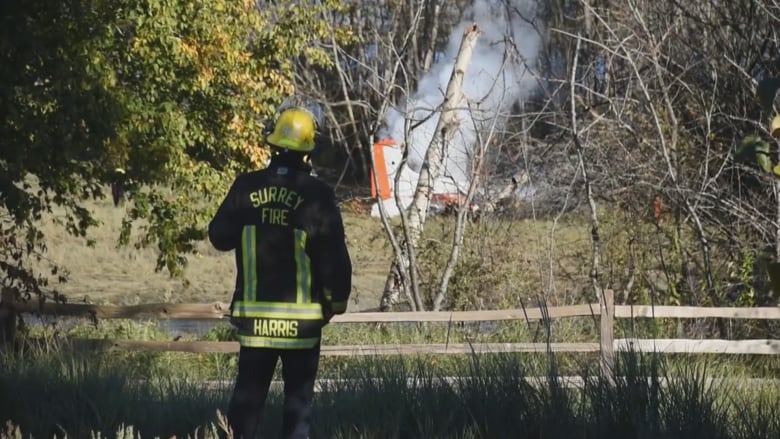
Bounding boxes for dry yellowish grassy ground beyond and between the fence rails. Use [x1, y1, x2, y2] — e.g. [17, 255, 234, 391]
[32, 193, 771, 350]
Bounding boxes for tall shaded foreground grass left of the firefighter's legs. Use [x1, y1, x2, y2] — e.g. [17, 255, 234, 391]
[0, 347, 229, 438]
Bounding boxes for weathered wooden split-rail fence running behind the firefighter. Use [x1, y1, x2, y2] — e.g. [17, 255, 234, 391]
[5, 290, 780, 367]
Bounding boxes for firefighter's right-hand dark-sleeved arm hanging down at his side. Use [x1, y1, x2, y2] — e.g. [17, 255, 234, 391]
[316, 191, 352, 315]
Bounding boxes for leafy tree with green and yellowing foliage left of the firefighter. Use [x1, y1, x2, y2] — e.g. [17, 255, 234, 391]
[0, 0, 346, 300]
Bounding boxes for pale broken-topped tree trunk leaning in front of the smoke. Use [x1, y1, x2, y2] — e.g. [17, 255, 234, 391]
[379, 24, 480, 311]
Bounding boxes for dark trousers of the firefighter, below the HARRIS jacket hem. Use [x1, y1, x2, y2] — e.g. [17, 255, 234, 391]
[227, 344, 320, 439]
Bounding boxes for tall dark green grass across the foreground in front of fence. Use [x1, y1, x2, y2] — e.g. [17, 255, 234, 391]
[0, 347, 780, 439]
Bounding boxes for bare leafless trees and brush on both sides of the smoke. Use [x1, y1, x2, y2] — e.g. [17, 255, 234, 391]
[310, 0, 778, 316]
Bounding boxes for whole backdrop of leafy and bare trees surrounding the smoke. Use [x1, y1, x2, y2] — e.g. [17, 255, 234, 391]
[0, 0, 780, 324]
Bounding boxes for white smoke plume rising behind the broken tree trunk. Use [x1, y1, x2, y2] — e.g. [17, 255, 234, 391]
[384, 0, 543, 190]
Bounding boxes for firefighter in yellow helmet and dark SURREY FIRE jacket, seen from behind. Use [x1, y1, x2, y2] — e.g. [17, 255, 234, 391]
[209, 99, 352, 438]
